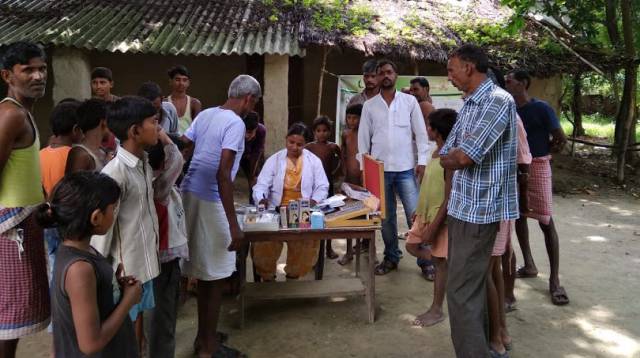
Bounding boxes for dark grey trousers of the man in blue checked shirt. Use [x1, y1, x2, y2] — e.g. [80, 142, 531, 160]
[447, 216, 500, 358]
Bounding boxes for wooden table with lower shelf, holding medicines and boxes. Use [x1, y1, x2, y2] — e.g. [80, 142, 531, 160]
[238, 226, 380, 327]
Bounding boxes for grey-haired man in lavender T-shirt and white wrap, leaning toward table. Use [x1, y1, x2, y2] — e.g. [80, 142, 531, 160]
[182, 75, 262, 357]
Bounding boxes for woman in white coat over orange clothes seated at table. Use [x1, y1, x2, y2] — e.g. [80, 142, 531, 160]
[252, 123, 329, 281]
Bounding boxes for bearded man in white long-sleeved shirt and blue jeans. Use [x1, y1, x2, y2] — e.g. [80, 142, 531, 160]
[358, 60, 429, 275]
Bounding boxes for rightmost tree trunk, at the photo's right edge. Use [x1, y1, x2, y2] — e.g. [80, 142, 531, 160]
[615, 0, 638, 183]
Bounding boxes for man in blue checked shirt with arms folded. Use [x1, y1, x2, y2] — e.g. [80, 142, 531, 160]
[440, 45, 519, 358]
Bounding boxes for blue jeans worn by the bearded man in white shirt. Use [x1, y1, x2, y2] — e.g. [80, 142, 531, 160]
[382, 169, 418, 263]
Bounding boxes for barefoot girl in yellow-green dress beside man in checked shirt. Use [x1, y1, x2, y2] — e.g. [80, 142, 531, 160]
[406, 108, 458, 327]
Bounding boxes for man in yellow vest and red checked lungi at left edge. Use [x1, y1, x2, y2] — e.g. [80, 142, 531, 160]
[0, 42, 50, 357]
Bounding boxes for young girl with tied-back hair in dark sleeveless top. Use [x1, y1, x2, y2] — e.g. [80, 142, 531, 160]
[36, 172, 142, 358]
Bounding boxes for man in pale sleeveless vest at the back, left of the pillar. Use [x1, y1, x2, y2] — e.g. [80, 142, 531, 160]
[167, 65, 202, 134]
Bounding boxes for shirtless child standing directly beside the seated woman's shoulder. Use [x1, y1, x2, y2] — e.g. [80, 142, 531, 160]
[306, 116, 342, 259]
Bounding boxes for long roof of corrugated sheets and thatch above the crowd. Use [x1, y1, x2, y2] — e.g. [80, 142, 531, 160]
[0, 0, 620, 76]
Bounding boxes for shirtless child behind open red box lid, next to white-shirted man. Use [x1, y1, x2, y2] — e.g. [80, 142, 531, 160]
[338, 104, 362, 265]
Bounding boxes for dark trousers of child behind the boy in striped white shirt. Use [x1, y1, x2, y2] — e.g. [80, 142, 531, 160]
[144, 259, 181, 358]
